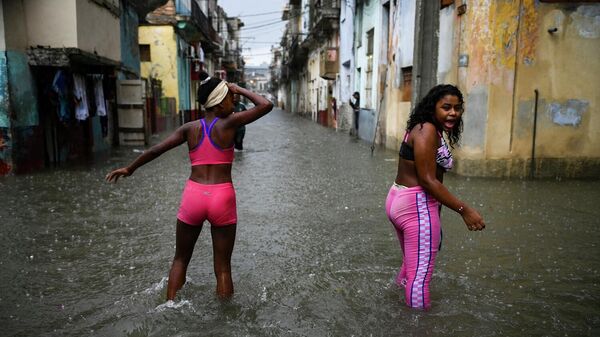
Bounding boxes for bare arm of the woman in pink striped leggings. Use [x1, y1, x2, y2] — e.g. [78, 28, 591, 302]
[412, 123, 485, 230]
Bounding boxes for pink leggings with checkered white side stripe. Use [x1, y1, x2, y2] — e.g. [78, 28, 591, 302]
[385, 185, 440, 309]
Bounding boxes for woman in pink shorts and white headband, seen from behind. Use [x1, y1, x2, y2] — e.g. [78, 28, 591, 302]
[106, 72, 273, 300]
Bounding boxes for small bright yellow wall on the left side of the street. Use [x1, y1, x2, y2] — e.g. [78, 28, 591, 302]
[138, 26, 179, 107]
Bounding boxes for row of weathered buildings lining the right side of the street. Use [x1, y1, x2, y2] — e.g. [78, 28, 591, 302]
[282, 0, 600, 177]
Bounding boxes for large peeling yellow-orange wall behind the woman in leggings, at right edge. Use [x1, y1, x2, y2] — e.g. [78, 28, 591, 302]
[446, 0, 600, 176]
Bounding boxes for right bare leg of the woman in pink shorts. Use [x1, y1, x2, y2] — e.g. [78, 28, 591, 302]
[210, 224, 237, 298]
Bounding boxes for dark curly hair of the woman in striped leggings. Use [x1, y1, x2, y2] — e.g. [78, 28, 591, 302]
[406, 84, 464, 147]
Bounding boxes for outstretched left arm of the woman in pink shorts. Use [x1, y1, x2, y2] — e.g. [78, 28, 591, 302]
[105, 124, 188, 183]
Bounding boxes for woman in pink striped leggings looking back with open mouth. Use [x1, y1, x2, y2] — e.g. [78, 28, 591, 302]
[385, 85, 485, 309]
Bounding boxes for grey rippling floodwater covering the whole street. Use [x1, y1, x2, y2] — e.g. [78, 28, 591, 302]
[0, 110, 600, 336]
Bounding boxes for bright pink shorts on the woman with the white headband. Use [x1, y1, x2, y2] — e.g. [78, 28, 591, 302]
[177, 180, 237, 226]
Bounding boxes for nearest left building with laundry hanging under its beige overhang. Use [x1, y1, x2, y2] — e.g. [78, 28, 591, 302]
[0, 0, 137, 174]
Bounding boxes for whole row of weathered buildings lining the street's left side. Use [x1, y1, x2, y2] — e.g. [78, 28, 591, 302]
[0, 0, 243, 175]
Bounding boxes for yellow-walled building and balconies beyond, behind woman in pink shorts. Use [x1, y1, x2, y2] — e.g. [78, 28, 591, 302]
[139, 0, 243, 122]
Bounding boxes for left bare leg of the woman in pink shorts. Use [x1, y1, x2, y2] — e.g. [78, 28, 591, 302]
[167, 220, 202, 301]
